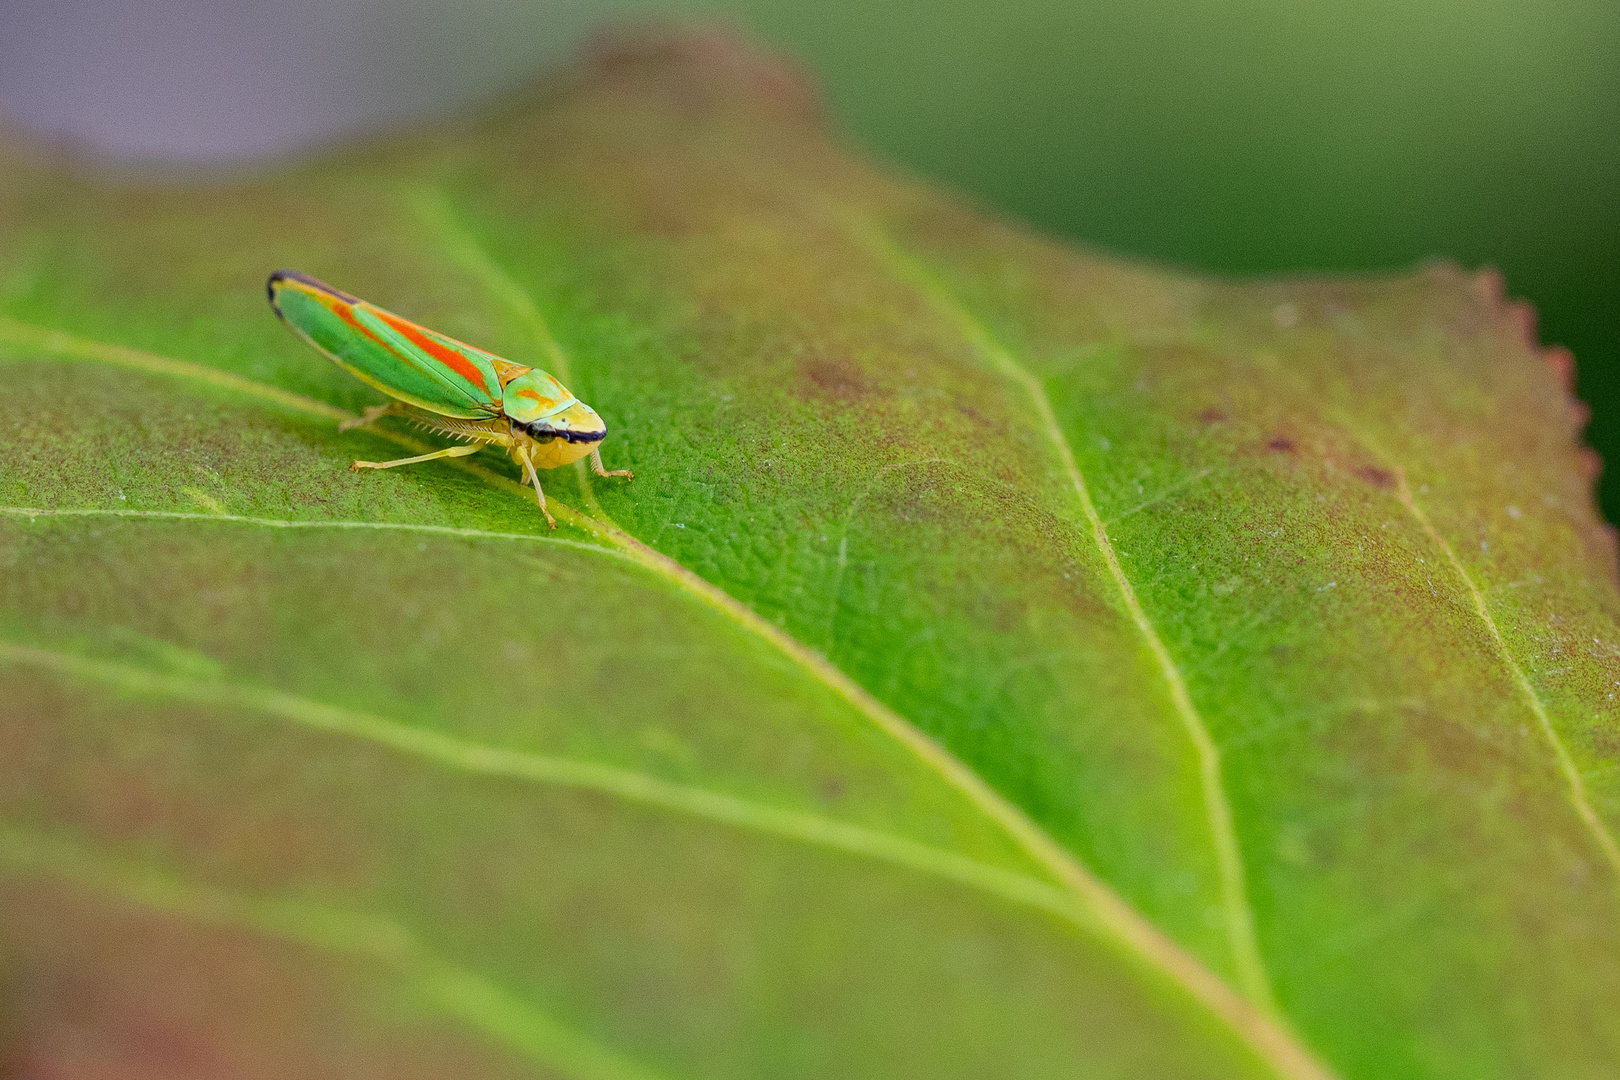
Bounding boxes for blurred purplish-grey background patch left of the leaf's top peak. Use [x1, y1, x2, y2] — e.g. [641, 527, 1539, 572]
[0, 0, 633, 162]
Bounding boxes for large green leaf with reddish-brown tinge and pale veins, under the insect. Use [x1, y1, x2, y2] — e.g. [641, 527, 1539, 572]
[0, 25, 1620, 1080]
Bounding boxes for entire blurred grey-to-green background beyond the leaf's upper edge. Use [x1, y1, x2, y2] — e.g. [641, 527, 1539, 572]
[9, 0, 1620, 520]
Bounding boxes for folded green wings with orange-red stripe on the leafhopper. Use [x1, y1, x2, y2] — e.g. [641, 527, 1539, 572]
[269, 270, 501, 419]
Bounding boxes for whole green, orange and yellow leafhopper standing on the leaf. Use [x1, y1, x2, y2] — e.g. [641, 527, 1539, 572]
[266, 270, 633, 528]
